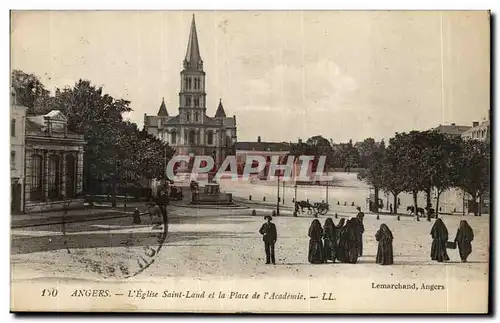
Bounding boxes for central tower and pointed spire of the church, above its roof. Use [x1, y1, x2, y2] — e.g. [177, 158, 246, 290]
[179, 15, 206, 126]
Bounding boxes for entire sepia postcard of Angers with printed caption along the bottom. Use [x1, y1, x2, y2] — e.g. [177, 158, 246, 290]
[10, 11, 491, 313]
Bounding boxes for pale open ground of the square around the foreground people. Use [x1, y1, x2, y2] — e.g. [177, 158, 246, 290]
[11, 202, 489, 281]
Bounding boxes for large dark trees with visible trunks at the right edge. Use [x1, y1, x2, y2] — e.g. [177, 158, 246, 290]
[360, 131, 490, 217]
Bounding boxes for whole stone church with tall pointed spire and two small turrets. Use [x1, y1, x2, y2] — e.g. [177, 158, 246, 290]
[144, 15, 237, 164]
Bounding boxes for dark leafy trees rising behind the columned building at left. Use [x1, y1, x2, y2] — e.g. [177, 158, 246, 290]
[12, 70, 174, 201]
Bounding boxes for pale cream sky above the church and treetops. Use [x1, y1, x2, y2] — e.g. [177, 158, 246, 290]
[11, 11, 490, 142]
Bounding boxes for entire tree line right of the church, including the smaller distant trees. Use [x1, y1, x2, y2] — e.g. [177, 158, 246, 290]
[291, 131, 490, 218]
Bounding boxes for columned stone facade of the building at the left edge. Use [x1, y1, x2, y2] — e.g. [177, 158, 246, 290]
[24, 110, 85, 213]
